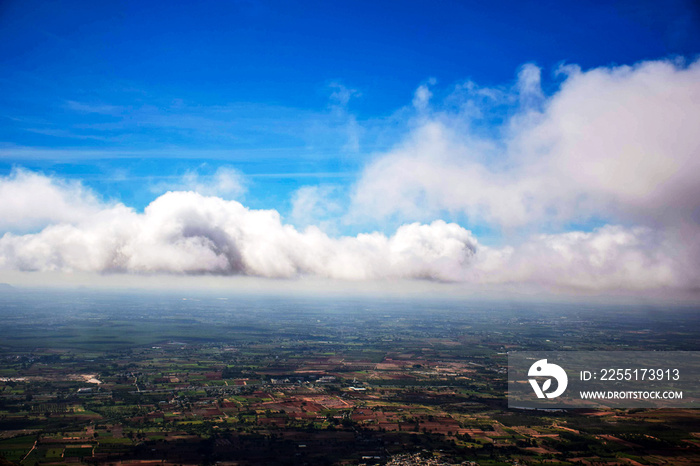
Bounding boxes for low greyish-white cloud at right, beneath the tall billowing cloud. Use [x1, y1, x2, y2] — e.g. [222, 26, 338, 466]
[474, 225, 698, 291]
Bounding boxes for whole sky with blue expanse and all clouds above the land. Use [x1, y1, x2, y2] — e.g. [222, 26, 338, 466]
[0, 0, 700, 300]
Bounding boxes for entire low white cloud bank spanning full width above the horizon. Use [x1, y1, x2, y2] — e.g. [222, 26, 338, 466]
[0, 173, 700, 291]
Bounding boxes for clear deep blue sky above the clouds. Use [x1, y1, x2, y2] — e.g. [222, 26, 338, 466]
[0, 1, 700, 207]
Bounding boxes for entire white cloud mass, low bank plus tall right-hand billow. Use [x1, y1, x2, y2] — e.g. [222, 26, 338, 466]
[0, 61, 700, 292]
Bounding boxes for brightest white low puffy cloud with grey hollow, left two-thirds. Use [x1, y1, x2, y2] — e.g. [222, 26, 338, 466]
[0, 184, 476, 280]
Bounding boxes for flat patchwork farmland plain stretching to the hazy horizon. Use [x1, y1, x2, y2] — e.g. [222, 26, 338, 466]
[0, 294, 700, 465]
